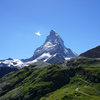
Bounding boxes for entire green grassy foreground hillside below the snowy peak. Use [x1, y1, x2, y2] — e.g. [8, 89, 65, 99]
[0, 58, 100, 100]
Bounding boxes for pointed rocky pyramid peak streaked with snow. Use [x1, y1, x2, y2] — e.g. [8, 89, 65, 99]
[30, 30, 77, 64]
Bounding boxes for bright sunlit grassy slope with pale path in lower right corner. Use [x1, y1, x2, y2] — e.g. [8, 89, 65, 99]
[41, 75, 100, 100]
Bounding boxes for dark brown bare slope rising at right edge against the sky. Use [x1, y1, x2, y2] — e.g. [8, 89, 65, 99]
[80, 46, 100, 58]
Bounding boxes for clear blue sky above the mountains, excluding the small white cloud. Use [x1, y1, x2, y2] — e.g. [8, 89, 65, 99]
[0, 0, 100, 59]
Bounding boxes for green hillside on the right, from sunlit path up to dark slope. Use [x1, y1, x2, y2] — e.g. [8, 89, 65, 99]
[40, 58, 100, 100]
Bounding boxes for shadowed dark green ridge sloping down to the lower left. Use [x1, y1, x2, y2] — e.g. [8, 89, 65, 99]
[0, 65, 74, 100]
